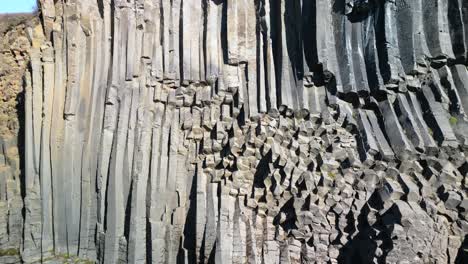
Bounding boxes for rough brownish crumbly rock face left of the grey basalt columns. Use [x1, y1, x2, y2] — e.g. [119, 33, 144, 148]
[0, 15, 39, 263]
